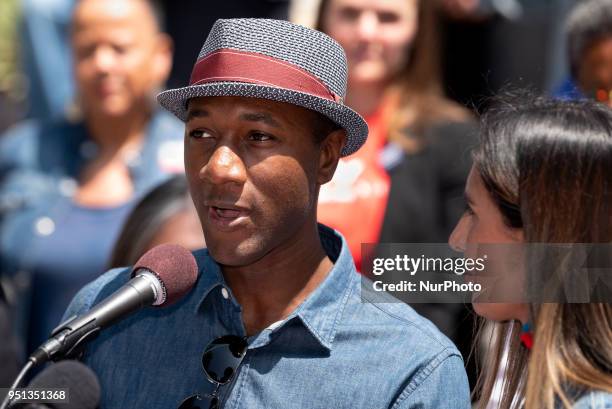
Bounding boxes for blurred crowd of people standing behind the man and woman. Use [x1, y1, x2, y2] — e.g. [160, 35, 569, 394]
[0, 0, 612, 402]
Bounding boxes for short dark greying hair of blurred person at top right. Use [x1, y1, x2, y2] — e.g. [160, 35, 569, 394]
[565, 0, 612, 79]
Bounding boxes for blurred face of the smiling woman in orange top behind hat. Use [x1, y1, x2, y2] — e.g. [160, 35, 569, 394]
[321, 0, 418, 86]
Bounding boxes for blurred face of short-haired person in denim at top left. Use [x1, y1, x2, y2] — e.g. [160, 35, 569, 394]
[72, 0, 171, 117]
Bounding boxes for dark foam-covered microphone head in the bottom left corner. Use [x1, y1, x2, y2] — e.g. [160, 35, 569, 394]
[9, 361, 100, 409]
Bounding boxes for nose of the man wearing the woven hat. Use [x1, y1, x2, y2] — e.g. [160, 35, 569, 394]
[201, 146, 246, 185]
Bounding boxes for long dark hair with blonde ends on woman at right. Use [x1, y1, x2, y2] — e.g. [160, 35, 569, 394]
[474, 93, 612, 408]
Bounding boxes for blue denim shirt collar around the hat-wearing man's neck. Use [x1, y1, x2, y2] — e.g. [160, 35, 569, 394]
[195, 224, 359, 352]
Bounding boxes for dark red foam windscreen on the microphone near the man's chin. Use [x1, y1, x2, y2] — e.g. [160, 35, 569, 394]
[132, 244, 198, 307]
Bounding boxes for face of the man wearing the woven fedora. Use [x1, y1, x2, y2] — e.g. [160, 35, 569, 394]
[185, 97, 342, 266]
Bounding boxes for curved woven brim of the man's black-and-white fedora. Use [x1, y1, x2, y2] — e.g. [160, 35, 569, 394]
[157, 82, 368, 156]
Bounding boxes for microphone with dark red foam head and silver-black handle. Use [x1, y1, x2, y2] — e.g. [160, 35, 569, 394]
[29, 244, 198, 365]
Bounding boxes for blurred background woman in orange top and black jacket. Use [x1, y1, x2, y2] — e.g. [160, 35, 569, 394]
[310, 0, 476, 372]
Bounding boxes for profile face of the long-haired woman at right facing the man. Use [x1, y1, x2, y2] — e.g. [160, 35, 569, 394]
[448, 167, 529, 322]
